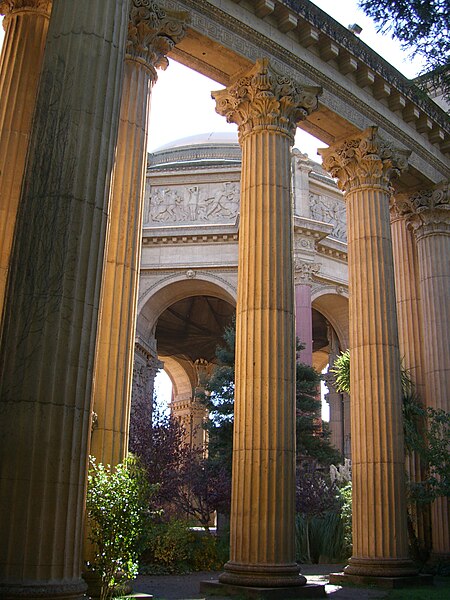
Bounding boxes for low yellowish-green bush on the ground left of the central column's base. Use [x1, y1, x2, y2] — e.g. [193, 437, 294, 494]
[140, 519, 228, 575]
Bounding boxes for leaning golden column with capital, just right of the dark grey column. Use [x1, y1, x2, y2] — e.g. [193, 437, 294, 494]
[91, 0, 186, 465]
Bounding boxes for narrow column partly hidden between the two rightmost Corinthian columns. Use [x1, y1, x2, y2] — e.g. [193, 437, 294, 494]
[390, 194, 429, 548]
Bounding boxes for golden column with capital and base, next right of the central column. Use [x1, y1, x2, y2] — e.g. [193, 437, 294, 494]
[320, 127, 417, 577]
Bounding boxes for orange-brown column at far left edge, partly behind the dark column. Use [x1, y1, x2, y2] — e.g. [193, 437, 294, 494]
[0, 0, 52, 318]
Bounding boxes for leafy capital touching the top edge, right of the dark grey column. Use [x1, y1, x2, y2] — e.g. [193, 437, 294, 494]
[125, 0, 189, 83]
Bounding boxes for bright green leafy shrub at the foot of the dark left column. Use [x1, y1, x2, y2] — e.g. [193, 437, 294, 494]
[86, 456, 153, 600]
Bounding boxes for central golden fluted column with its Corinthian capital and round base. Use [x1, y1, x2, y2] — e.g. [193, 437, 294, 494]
[213, 59, 320, 587]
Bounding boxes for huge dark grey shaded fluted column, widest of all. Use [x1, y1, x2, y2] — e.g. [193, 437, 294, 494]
[0, 0, 128, 600]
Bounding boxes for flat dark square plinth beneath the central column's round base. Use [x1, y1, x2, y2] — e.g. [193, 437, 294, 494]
[200, 580, 326, 600]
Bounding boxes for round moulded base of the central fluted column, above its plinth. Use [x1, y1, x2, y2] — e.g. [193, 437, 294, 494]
[219, 561, 306, 588]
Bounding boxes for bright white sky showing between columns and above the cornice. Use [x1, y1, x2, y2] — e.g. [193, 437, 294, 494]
[0, 0, 422, 408]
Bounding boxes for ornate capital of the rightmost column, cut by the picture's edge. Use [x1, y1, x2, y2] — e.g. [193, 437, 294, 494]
[407, 181, 450, 239]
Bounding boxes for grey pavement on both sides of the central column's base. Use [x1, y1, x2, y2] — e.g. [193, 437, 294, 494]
[133, 565, 387, 600]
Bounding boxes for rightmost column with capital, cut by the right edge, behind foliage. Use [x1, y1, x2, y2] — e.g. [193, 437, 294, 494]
[409, 182, 450, 560]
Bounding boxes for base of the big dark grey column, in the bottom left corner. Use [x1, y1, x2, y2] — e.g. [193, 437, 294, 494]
[0, 579, 87, 600]
